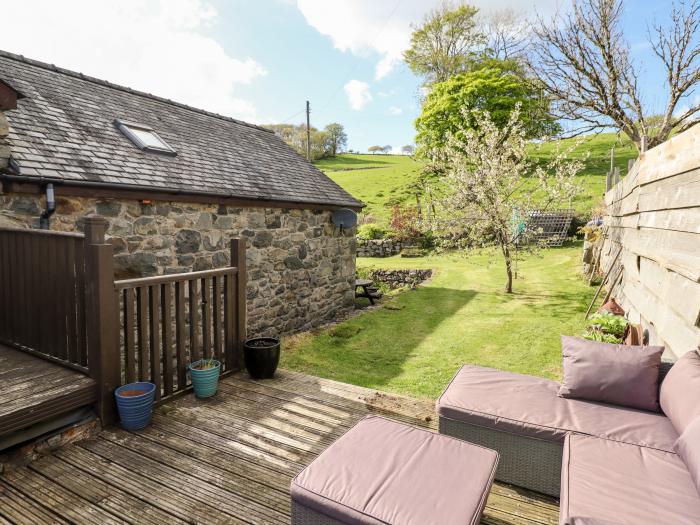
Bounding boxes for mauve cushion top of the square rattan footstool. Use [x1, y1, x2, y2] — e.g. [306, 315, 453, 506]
[291, 416, 498, 525]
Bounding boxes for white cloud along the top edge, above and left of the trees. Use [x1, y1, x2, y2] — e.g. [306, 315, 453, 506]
[297, 0, 561, 80]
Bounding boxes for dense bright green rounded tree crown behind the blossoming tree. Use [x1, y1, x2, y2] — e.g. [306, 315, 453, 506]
[416, 59, 559, 154]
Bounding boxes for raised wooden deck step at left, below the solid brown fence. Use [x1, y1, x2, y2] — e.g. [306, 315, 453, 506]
[0, 345, 95, 438]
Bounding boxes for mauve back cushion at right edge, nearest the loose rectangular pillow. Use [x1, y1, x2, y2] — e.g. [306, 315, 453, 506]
[660, 351, 700, 434]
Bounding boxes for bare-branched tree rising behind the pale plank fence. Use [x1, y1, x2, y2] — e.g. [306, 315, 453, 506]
[529, 0, 700, 151]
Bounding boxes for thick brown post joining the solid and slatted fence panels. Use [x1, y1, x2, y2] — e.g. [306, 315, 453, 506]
[83, 215, 121, 425]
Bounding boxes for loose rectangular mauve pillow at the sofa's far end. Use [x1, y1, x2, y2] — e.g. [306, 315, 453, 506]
[559, 336, 664, 412]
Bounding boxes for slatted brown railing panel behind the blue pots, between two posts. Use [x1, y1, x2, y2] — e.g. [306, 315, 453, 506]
[114, 240, 246, 401]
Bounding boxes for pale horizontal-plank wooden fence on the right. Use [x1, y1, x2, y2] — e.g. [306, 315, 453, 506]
[601, 126, 700, 357]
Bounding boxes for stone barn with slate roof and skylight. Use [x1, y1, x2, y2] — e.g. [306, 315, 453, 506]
[0, 52, 362, 334]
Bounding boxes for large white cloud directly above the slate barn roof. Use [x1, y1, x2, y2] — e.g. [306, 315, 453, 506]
[0, 0, 266, 121]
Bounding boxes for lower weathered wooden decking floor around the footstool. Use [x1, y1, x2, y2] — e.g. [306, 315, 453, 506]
[0, 372, 558, 525]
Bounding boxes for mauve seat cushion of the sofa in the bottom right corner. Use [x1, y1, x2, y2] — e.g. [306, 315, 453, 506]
[560, 434, 700, 525]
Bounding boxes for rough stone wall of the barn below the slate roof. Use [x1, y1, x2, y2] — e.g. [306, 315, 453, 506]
[0, 194, 355, 335]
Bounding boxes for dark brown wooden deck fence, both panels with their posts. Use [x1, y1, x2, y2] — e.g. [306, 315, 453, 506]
[0, 216, 246, 424]
